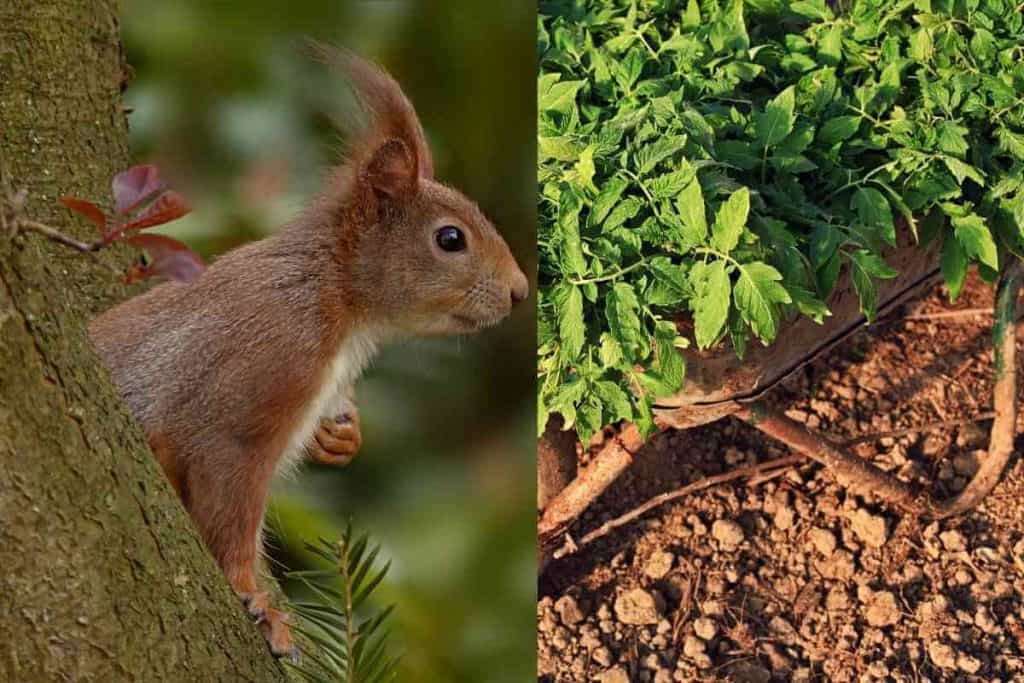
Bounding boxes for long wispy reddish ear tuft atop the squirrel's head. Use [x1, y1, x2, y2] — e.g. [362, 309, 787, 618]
[309, 41, 434, 179]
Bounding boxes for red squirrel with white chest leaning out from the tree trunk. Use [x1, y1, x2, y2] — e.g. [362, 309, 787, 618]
[89, 49, 527, 657]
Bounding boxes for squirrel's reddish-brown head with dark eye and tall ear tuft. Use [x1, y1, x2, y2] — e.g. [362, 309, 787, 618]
[319, 48, 528, 335]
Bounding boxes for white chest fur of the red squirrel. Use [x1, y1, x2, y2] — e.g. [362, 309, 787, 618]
[278, 331, 377, 471]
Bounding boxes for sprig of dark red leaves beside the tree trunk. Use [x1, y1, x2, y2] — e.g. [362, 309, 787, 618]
[58, 165, 206, 283]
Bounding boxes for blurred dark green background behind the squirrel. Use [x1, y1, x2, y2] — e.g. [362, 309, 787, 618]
[122, 0, 536, 682]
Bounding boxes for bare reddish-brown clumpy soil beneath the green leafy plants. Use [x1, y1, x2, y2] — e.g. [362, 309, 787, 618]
[537, 278, 1024, 683]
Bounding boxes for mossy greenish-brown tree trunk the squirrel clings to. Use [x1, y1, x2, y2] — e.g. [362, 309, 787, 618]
[0, 0, 287, 682]
